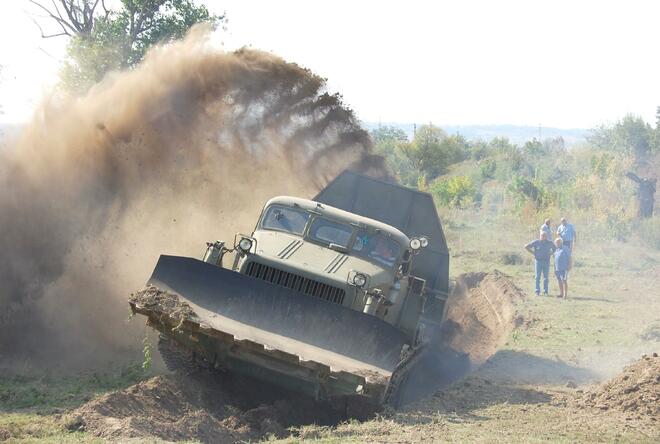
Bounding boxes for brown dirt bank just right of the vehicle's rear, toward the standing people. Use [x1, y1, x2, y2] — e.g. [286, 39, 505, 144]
[447, 270, 525, 364]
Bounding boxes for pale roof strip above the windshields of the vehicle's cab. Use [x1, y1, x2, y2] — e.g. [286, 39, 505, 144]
[264, 196, 410, 248]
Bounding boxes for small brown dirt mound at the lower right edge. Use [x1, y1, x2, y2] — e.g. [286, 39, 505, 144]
[577, 353, 660, 418]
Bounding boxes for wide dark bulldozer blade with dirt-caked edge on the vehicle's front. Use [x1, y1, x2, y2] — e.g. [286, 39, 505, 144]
[137, 255, 407, 402]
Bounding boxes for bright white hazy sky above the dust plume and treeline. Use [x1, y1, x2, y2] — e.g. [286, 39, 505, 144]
[0, 0, 660, 127]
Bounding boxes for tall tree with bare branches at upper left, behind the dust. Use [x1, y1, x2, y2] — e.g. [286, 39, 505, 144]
[29, 0, 224, 92]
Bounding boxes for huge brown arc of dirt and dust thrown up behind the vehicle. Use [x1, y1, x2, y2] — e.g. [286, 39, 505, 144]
[0, 28, 386, 370]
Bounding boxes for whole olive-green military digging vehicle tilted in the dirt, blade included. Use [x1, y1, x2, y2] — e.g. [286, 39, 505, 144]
[130, 171, 448, 405]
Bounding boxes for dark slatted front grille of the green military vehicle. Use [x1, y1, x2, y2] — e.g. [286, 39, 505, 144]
[245, 262, 346, 304]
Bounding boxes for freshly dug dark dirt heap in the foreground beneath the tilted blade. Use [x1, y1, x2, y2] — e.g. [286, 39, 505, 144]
[64, 372, 342, 443]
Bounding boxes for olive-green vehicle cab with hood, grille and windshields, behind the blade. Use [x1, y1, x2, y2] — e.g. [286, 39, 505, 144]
[236, 196, 428, 332]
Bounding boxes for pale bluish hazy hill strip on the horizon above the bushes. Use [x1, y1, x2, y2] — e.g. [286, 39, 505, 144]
[362, 122, 589, 146]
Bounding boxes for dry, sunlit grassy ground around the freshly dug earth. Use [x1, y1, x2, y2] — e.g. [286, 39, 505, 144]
[0, 214, 660, 442]
